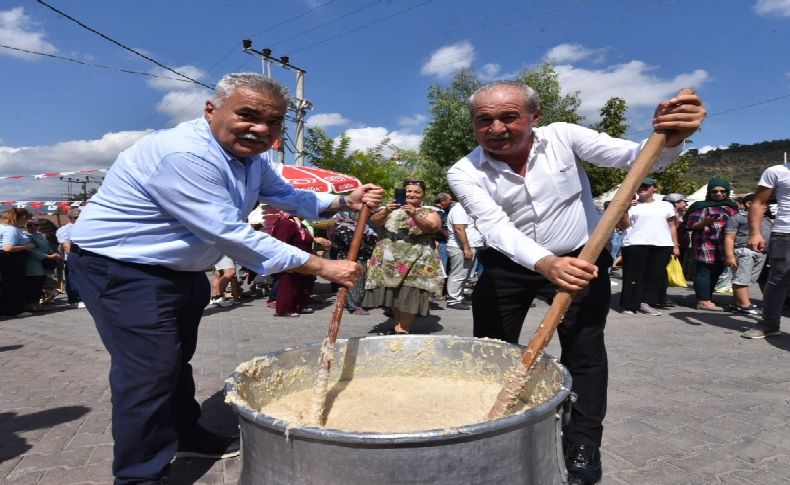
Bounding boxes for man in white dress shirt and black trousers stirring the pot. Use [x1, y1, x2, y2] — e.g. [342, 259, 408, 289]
[447, 81, 705, 484]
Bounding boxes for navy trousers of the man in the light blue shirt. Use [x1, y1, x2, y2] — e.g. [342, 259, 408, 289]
[69, 249, 211, 485]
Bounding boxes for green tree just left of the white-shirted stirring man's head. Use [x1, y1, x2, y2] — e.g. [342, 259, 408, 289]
[420, 69, 482, 167]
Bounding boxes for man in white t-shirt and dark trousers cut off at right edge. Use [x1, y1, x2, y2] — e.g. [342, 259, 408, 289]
[741, 163, 790, 339]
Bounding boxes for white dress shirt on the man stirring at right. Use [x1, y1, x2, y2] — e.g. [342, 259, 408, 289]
[447, 123, 683, 270]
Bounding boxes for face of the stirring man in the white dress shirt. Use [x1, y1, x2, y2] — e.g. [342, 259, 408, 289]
[472, 86, 540, 162]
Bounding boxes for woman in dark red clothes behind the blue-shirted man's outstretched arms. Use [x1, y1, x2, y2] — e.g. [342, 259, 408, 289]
[272, 211, 315, 317]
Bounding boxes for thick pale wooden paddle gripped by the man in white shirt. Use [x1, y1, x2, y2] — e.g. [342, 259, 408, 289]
[488, 88, 694, 419]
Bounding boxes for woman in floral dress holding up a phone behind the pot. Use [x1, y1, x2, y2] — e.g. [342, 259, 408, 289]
[362, 180, 444, 334]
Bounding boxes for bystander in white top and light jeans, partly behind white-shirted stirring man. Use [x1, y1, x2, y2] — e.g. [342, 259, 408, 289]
[447, 204, 484, 310]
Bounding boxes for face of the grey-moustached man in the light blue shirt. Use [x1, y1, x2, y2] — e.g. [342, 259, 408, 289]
[205, 87, 288, 157]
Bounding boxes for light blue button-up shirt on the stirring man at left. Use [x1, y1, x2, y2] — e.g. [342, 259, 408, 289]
[71, 118, 334, 274]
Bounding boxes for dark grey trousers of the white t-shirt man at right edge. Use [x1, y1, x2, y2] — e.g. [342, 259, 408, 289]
[763, 232, 790, 330]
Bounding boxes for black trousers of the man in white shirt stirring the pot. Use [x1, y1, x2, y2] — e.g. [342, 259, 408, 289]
[472, 248, 612, 446]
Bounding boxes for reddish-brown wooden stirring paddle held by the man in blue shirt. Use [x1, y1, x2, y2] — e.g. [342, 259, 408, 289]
[308, 204, 370, 426]
